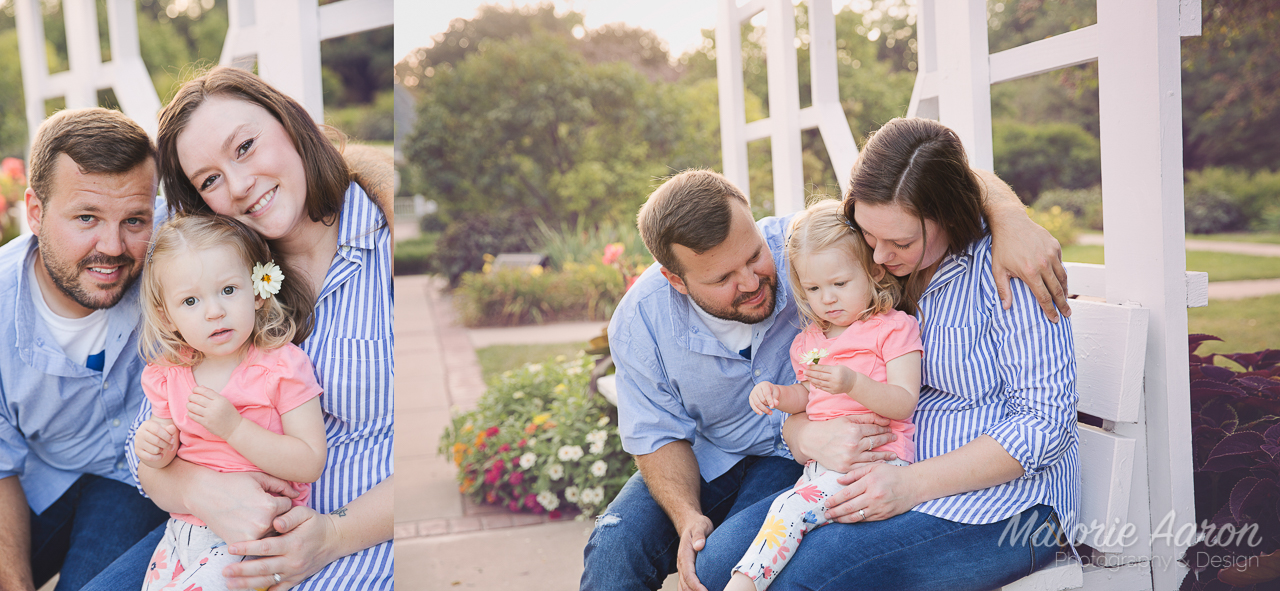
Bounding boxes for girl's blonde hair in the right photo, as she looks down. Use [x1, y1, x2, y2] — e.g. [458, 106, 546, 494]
[787, 200, 902, 330]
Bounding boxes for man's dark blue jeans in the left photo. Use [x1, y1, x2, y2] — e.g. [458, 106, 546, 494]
[31, 475, 169, 591]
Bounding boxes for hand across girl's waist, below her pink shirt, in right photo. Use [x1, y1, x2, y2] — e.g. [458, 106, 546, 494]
[782, 414, 897, 472]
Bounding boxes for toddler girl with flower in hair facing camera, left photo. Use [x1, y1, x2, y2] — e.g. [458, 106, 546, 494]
[134, 215, 326, 591]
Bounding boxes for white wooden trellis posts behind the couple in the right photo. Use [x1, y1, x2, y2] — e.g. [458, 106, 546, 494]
[716, 0, 858, 215]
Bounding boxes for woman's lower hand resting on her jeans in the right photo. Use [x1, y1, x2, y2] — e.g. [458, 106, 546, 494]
[823, 463, 925, 523]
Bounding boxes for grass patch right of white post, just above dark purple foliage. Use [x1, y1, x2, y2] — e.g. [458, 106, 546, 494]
[1187, 296, 1280, 354]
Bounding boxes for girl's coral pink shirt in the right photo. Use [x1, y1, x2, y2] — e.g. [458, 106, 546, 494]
[791, 310, 924, 462]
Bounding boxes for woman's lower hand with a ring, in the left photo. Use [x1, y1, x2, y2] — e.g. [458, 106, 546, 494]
[223, 507, 339, 591]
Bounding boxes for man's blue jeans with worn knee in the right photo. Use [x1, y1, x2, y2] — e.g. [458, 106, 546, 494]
[581, 457, 804, 591]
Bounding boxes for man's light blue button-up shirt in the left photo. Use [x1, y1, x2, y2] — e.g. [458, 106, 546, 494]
[0, 234, 143, 513]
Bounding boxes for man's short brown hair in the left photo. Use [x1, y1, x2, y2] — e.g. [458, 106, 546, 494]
[29, 107, 156, 205]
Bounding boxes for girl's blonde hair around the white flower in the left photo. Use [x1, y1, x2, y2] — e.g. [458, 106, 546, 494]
[138, 215, 315, 367]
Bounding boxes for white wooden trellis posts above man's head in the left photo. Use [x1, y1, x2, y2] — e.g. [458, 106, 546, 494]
[14, 0, 160, 136]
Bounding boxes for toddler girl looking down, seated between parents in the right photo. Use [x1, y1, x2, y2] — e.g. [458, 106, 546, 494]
[726, 201, 922, 590]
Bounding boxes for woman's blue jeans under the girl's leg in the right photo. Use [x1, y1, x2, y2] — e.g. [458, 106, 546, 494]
[698, 495, 1065, 591]
